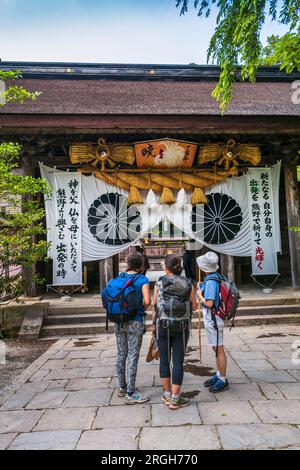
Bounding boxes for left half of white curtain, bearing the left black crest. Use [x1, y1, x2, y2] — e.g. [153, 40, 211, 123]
[81, 175, 163, 261]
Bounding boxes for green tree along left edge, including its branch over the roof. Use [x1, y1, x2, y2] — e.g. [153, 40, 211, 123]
[0, 71, 49, 300]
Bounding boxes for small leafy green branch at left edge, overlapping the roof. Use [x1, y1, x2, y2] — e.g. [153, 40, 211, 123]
[0, 70, 41, 106]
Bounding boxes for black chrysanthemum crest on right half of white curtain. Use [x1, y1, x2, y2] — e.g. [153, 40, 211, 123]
[191, 193, 243, 245]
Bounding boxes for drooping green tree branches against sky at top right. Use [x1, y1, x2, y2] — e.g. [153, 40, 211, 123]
[176, 0, 300, 113]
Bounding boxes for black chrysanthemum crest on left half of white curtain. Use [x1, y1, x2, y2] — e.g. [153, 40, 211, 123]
[87, 193, 142, 246]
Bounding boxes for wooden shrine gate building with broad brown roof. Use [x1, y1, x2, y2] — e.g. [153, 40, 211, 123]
[0, 62, 300, 296]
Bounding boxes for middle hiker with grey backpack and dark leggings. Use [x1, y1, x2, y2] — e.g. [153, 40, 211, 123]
[152, 254, 197, 410]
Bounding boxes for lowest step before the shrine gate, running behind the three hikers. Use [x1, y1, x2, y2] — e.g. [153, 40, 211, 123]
[42, 313, 300, 338]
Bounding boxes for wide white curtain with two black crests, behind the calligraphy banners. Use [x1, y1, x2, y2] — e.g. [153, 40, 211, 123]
[40, 162, 281, 261]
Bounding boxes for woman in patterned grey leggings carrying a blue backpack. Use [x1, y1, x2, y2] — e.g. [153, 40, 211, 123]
[102, 252, 151, 405]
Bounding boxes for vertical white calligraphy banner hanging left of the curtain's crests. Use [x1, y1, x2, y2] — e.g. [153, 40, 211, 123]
[53, 172, 82, 285]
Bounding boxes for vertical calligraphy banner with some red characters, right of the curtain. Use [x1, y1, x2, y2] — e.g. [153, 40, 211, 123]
[247, 168, 278, 276]
